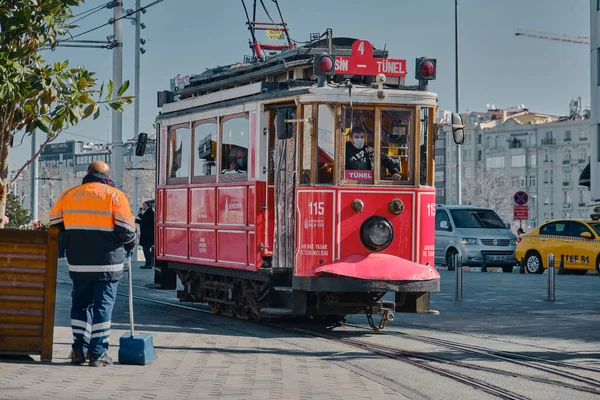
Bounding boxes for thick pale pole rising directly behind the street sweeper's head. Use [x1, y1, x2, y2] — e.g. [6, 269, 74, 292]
[111, 1, 123, 190]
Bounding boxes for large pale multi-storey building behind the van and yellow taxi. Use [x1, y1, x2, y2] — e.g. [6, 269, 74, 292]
[436, 103, 591, 228]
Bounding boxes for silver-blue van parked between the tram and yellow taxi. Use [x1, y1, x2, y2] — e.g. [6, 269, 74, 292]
[435, 205, 517, 272]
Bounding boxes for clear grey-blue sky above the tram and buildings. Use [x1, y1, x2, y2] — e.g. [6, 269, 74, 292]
[10, 0, 590, 169]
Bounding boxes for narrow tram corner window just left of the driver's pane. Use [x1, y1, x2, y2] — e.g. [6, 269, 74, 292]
[317, 104, 335, 184]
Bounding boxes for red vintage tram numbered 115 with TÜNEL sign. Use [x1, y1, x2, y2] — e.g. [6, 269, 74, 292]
[142, 26, 464, 326]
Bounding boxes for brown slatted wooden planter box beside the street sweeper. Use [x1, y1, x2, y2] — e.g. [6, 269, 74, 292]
[0, 227, 59, 361]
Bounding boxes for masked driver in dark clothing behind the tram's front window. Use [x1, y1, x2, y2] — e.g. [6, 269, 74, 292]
[346, 126, 402, 181]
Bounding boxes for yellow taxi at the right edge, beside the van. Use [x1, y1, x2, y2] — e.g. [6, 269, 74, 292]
[515, 219, 600, 275]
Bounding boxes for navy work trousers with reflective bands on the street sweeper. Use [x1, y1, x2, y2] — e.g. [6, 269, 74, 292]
[71, 280, 118, 360]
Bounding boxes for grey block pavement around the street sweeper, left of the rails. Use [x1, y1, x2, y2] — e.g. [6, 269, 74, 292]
[0, 263, 404, 400]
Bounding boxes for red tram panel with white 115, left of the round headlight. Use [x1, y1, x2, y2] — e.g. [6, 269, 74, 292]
[294, 191, 335, 276]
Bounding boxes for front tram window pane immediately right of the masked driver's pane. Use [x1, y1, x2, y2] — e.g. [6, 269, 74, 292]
[380, 110, 412, 181]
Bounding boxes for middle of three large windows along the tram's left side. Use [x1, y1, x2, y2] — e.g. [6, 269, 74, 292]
[194, 120, 217, 180]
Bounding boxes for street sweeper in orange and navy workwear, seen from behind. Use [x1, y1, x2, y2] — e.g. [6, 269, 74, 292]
[50, 161, 136, 367]
